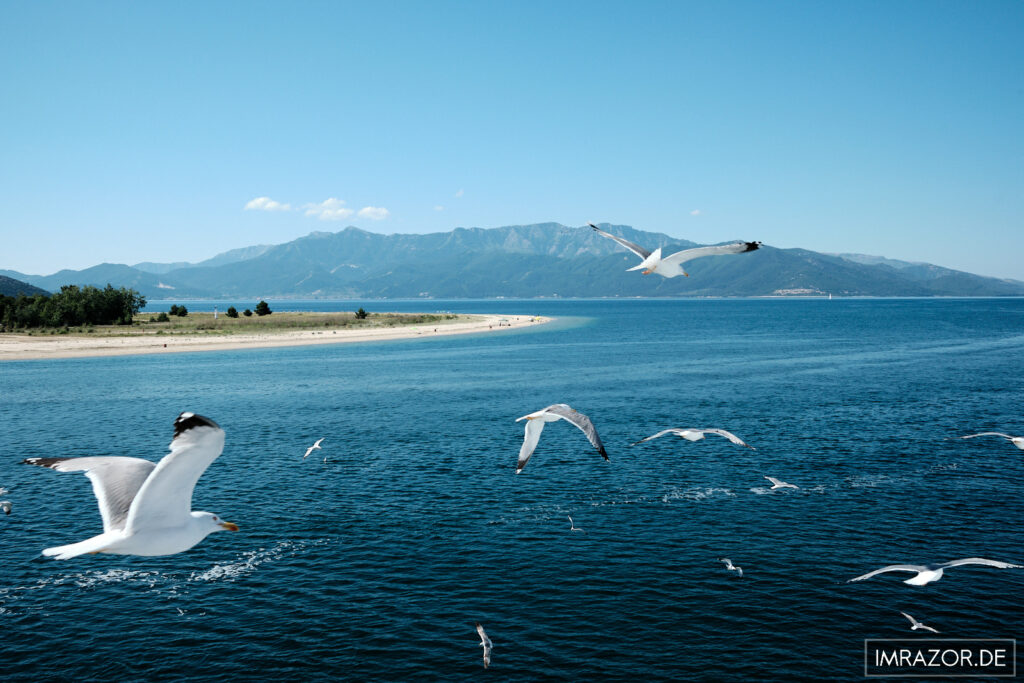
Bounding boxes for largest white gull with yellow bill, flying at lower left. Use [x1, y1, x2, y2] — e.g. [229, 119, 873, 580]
[23, 413, 239, 560]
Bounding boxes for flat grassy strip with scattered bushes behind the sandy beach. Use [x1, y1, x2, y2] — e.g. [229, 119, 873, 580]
[17, 311, 468, 337]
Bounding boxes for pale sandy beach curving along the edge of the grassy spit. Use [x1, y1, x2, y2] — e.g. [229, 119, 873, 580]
[0, 315, 551, 361]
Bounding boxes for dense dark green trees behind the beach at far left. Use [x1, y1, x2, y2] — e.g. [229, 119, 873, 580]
[0, 285, 145, 332]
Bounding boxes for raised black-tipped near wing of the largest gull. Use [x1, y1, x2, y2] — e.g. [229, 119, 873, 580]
[125, 413, 224, 531]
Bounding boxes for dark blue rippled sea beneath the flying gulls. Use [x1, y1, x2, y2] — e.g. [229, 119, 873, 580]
[0, 299, 1024, 681]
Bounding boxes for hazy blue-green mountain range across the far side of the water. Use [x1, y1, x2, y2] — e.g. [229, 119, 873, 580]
[0, 223, 1024, 299]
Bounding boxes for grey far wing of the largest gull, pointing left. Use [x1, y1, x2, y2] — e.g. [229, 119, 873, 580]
[23, 456, 157, 531]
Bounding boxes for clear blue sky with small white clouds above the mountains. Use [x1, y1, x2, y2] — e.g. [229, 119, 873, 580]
[0, 0, 1024, 280]
